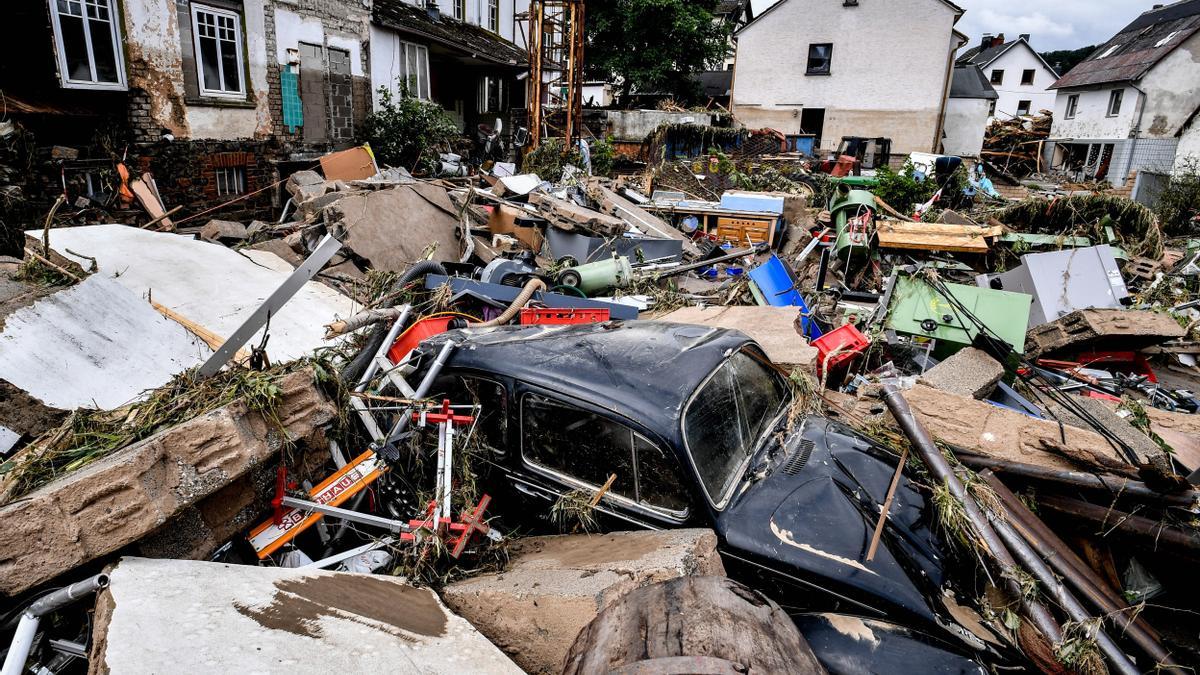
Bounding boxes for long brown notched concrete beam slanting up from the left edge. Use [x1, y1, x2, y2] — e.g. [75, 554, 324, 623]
[0, 369, 337, 596]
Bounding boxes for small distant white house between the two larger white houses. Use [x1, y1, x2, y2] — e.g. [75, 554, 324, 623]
[958, 34, 1058, 119]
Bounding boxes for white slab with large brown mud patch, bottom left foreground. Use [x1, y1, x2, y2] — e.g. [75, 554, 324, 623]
[89, 557, 521, 674]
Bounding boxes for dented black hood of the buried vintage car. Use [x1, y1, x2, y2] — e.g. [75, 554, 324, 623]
[716, 417, 946, 625]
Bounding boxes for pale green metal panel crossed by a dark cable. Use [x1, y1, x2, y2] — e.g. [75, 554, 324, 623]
[884, 274, 1033, 353]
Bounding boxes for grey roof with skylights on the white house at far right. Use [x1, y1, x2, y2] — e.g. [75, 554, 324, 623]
[1050, 0, 1200, 89]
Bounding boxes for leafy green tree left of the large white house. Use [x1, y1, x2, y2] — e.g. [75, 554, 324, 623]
[583, 0, 731, 100]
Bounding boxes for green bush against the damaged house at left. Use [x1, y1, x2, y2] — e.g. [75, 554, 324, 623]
[362, 86, 462, 173]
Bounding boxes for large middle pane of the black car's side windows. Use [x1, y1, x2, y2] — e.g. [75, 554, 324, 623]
[521, 394, 636, 500]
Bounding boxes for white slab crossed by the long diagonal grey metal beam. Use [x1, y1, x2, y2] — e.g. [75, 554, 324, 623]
[30, 225, 355, 363]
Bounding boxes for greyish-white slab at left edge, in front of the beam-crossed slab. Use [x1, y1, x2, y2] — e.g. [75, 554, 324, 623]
[0, 271, 212, 410]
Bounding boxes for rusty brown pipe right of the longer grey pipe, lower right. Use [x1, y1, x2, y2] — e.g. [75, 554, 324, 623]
[979, 471, 1183, 675]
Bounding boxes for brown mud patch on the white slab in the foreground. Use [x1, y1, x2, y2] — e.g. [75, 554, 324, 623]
[235, 574, 446, 640]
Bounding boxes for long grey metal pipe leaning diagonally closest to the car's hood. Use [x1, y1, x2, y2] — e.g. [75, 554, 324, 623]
[883, 384, 1062, 643]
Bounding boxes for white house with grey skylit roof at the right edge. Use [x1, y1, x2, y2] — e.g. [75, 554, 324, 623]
[1043, 0, 1200, 190]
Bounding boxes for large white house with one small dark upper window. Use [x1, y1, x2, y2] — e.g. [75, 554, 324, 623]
[731, 0, 966, 156]
